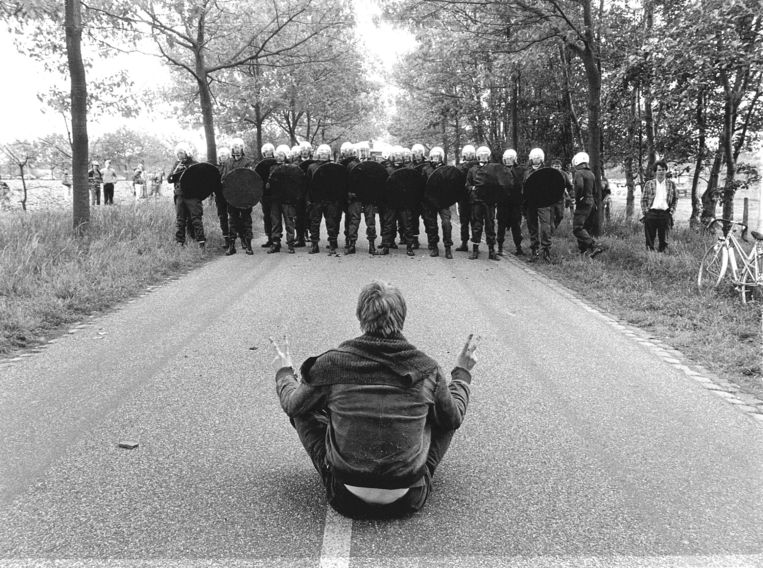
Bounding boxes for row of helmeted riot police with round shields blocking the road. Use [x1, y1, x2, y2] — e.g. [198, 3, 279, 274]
[171, 138, 592, 260]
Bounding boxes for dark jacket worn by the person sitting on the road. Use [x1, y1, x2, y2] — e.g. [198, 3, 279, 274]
[276, 334, 471, 489]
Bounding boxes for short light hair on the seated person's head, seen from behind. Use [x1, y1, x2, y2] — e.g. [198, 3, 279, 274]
[355, 280, 407, 337]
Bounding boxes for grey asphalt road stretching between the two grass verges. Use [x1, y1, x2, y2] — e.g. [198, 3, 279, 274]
[0, 235, 763, 568]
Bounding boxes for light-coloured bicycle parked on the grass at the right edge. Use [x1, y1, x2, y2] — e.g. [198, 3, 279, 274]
[697, 219, 763, 303]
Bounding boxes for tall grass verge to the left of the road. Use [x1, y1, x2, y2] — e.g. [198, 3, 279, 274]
[0, 202, 221, 356]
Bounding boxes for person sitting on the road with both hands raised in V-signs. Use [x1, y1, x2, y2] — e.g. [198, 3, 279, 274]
[271, 281, 477, 518]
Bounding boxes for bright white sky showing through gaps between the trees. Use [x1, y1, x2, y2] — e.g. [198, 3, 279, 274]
[0, 0, 414, 143]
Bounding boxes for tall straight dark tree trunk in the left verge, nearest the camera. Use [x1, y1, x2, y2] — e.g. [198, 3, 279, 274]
[64, 0, 90, 234]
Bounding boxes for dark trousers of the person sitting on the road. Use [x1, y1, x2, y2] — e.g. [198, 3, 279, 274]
[291, 412, 455, 519]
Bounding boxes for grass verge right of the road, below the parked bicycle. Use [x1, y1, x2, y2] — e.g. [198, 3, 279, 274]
[533, 213, 763, 400]
